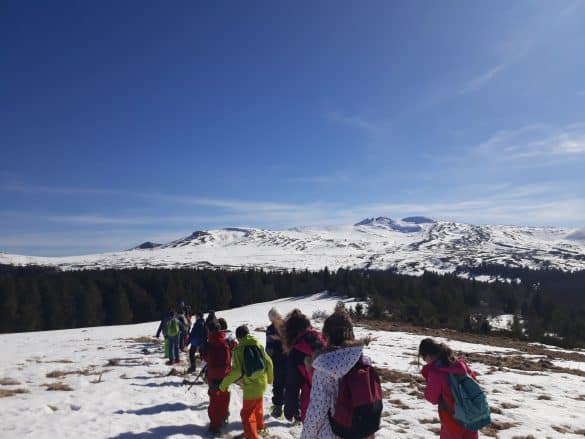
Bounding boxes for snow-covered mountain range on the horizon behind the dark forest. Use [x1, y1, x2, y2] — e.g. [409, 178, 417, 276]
[0, 217, 585, 274]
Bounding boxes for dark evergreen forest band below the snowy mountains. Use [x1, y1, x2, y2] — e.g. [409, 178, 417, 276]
[0, 266, 585, 346]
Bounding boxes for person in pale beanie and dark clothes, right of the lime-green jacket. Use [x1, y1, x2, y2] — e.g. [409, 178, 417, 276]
[266, 308, 286, 418]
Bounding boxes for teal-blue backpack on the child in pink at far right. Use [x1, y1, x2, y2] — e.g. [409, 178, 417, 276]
[449, 374, 492, 430]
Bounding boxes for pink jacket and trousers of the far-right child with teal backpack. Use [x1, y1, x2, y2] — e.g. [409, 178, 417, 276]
[422, 359, 477, 438]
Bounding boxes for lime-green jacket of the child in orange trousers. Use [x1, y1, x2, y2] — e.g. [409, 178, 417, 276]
[219, 334, 274, 400]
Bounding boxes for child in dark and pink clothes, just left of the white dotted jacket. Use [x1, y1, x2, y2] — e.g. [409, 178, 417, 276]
[283, 309, 325, 422]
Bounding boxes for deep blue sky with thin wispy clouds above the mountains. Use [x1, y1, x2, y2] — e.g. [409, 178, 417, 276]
[0, 0, 585, 255]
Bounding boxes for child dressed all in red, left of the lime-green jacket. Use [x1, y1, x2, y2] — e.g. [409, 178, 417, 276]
[201, 318, 232, 434]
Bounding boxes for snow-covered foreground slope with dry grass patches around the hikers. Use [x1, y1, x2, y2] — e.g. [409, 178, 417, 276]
[0, 295, 585, 439]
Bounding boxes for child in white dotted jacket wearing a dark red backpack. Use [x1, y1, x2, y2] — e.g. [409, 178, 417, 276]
[301, 311, 382, 439]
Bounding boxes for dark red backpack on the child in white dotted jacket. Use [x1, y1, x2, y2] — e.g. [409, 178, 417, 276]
[329, 358, 382, 439]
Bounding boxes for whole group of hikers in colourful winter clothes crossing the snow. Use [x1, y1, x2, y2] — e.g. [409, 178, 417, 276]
[156, 304, 490, 439]
